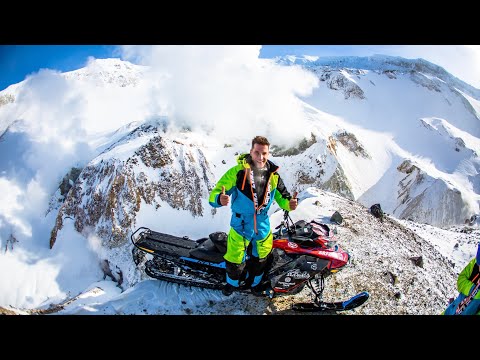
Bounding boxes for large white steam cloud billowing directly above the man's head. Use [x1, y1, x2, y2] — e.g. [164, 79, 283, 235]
[120, 45, 318, 145]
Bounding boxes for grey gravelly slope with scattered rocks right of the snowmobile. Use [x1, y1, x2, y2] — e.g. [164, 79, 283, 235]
[264, 188, 456, 315]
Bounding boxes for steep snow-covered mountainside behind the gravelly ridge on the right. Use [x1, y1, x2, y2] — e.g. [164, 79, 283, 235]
[280, 56, 480, 226]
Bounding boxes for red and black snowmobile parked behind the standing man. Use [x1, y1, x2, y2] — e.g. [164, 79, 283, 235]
[130, 210, 369, 311]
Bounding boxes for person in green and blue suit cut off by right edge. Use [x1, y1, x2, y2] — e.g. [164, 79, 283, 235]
[442, 243, 480, 315]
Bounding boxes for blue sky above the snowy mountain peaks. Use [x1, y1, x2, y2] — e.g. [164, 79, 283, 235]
[0, 45, 480, 91]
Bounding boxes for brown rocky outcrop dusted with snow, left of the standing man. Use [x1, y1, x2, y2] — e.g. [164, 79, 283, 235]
[50, 119, 213, 252]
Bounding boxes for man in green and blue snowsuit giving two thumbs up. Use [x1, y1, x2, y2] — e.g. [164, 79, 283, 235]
[209, 136, 298, 296]
